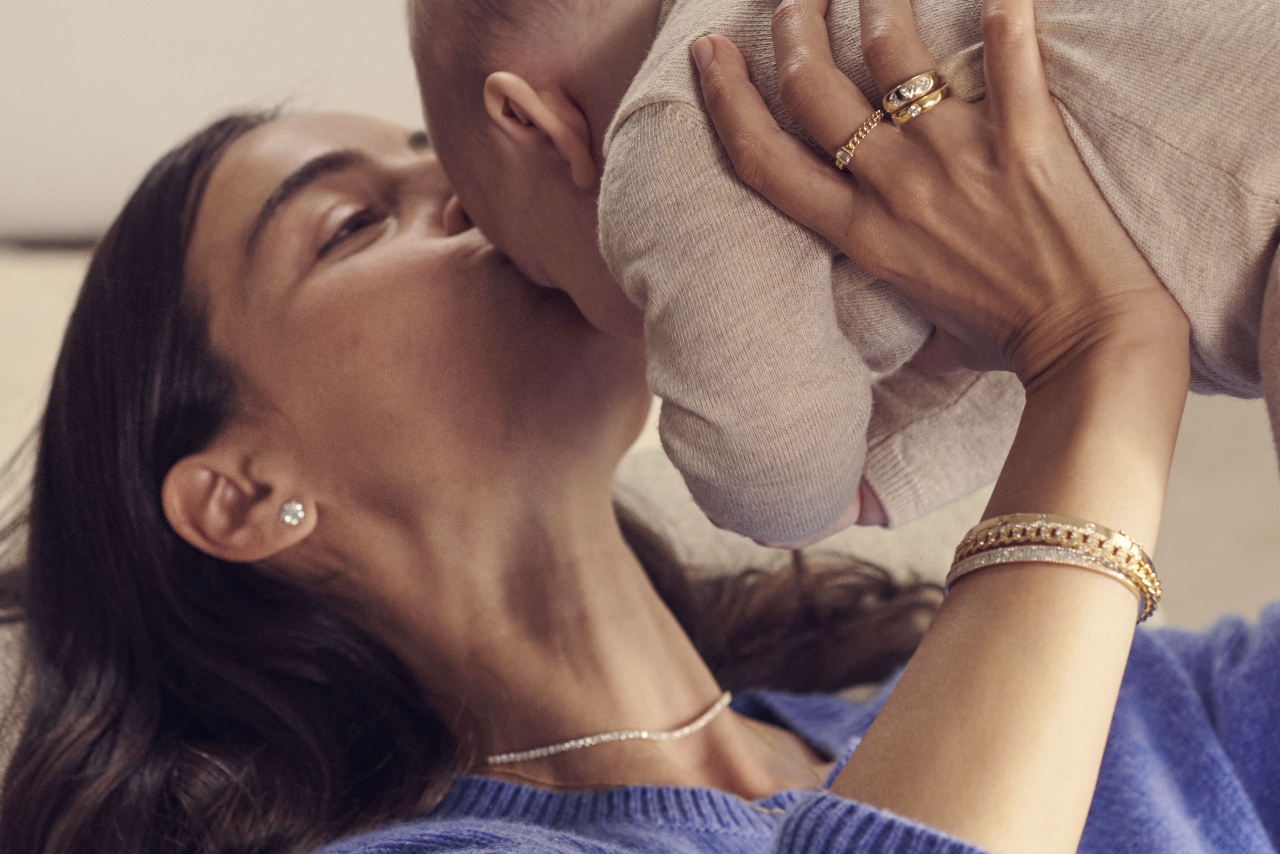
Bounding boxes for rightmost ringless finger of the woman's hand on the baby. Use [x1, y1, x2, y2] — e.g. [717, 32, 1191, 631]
[982, 0, 1056, 129]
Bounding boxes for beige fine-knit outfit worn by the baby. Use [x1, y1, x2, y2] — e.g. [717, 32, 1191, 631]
[599, 0, 1280, 542]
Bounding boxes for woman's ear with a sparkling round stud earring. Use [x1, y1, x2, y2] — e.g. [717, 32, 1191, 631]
[160, 434, 316, 563]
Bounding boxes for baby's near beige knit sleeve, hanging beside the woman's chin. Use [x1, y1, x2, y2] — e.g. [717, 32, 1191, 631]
[599, 102, 872, 543]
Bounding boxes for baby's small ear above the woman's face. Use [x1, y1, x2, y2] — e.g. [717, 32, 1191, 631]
[484, 72, 599, 189]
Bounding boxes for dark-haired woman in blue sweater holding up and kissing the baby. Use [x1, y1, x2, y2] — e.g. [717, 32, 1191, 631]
[0, 0, 1280, 851]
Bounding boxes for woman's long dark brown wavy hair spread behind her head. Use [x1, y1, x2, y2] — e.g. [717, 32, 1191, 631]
[0, 114, 938, 854]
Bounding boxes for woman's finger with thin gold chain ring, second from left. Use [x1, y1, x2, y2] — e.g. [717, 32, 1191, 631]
[773, 0, 873, 154]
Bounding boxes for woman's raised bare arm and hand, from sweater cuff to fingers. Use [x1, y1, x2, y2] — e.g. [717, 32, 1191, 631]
[695, 0, 1188, 851]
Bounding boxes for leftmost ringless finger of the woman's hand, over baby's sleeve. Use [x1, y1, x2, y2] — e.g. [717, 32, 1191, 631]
[692, 36, 865, 242]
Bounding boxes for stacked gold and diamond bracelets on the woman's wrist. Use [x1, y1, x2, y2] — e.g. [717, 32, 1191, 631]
[946, 513, 1160, 622]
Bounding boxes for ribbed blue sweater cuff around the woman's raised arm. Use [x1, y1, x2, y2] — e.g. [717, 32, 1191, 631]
[776, 793, 980, 854]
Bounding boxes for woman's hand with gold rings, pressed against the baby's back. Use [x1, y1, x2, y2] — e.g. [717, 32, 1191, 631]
[694, 0, 1185, 388]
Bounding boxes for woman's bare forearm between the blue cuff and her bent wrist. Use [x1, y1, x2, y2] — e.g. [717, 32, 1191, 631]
[832, 315, 1187, 853]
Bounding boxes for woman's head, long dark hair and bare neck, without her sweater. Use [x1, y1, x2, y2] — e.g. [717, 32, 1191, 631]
[0, 68, 936, 853]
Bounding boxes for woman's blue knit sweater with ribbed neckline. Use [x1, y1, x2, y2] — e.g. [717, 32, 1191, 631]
[314, 603, 1280, 854]
